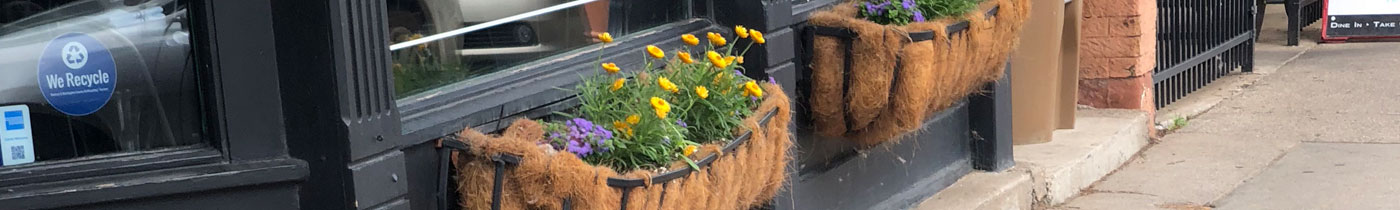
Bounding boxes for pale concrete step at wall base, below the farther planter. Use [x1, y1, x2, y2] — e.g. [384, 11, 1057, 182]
[913, 109, 1149, 210]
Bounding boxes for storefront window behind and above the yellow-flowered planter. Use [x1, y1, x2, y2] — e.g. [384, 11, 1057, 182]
[388, 0, 689, 98]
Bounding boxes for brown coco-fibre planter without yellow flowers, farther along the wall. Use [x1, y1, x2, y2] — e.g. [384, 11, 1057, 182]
[808, 0, 1029, 146]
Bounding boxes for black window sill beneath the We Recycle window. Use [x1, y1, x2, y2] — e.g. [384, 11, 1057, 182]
[0, 158, 309, 209]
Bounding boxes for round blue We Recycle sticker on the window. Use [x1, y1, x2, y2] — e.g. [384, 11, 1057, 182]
[39, 32, 116, 116]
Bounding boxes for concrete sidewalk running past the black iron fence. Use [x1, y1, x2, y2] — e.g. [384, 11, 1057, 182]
[1053, 4, 1400, 210]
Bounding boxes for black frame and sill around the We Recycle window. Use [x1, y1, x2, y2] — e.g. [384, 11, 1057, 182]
[0, 0, 307, 205]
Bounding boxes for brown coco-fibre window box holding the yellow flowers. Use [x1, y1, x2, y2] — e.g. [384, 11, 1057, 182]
[441, 84, 792, 209]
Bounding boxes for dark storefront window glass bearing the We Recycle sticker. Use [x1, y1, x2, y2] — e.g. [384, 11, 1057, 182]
[0, 0, 204, 167]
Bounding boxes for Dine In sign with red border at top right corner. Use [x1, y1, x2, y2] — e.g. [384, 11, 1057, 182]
[1322, 0, 1400, 41]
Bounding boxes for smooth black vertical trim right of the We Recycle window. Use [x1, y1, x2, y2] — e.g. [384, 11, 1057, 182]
[206, 0, 287, 161]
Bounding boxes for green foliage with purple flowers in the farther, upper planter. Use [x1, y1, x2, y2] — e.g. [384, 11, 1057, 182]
[855, 0, 981, 25]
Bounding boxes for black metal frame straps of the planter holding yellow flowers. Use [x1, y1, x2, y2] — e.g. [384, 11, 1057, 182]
[435, 109, 777, 210]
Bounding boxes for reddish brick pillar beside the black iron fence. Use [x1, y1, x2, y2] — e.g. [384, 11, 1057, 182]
[1079, 0, 1156, 116]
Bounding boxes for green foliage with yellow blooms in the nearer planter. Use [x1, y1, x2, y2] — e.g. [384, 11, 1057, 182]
[562, 32, 757, 171]
